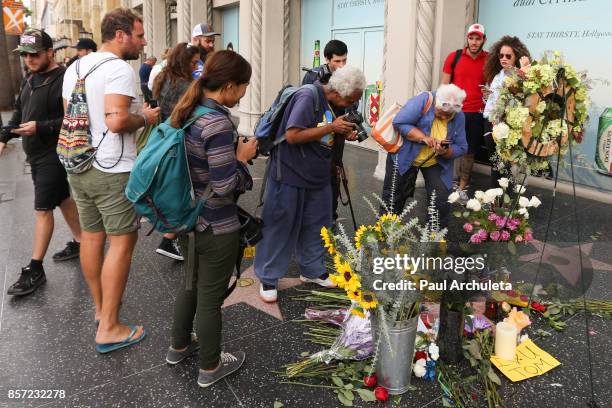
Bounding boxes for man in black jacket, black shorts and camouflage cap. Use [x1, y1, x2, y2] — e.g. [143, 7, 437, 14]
[0, 29, 81, 296]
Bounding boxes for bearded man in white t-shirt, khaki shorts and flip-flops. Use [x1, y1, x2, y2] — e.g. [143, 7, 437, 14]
[62, 8, 159, 353]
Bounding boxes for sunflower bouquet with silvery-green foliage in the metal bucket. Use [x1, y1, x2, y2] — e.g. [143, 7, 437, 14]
[321, 196, 446, 356]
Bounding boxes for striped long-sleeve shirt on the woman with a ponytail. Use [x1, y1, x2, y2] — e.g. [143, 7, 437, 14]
[185, 107, 253, 235]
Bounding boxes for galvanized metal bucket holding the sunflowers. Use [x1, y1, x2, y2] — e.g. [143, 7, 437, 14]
[372, 317, 418, 395]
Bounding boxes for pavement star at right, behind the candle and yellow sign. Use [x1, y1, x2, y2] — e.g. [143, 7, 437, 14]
[519, 240, 612, 285]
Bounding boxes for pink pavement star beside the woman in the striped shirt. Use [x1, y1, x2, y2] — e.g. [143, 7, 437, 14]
[223, 266, 302, 320]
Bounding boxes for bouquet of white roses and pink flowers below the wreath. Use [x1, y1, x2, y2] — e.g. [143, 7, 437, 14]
[448, 177, 542, 252]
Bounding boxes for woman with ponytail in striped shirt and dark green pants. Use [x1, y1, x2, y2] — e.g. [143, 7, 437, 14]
[166, 51, 256, 387]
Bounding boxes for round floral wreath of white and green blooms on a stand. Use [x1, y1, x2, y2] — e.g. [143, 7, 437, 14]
[490, 52, 589, 173]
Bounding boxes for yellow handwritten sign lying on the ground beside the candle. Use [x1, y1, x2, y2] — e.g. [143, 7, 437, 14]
[491, 340, 561, 382]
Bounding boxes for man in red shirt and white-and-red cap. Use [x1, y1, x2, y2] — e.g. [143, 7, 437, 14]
[441, 24, 488, 202]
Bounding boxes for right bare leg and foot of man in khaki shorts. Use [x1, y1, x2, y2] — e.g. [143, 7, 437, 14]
[96, 232, 144, 344]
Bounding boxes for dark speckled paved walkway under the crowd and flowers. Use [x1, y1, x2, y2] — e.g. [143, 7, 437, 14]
[0, 126, 612, 408]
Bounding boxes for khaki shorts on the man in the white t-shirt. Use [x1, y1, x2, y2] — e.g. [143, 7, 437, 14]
[68, 167, 139, 235]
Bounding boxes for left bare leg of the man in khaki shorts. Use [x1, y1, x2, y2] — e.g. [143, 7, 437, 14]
[81, 231, 106, 320]
